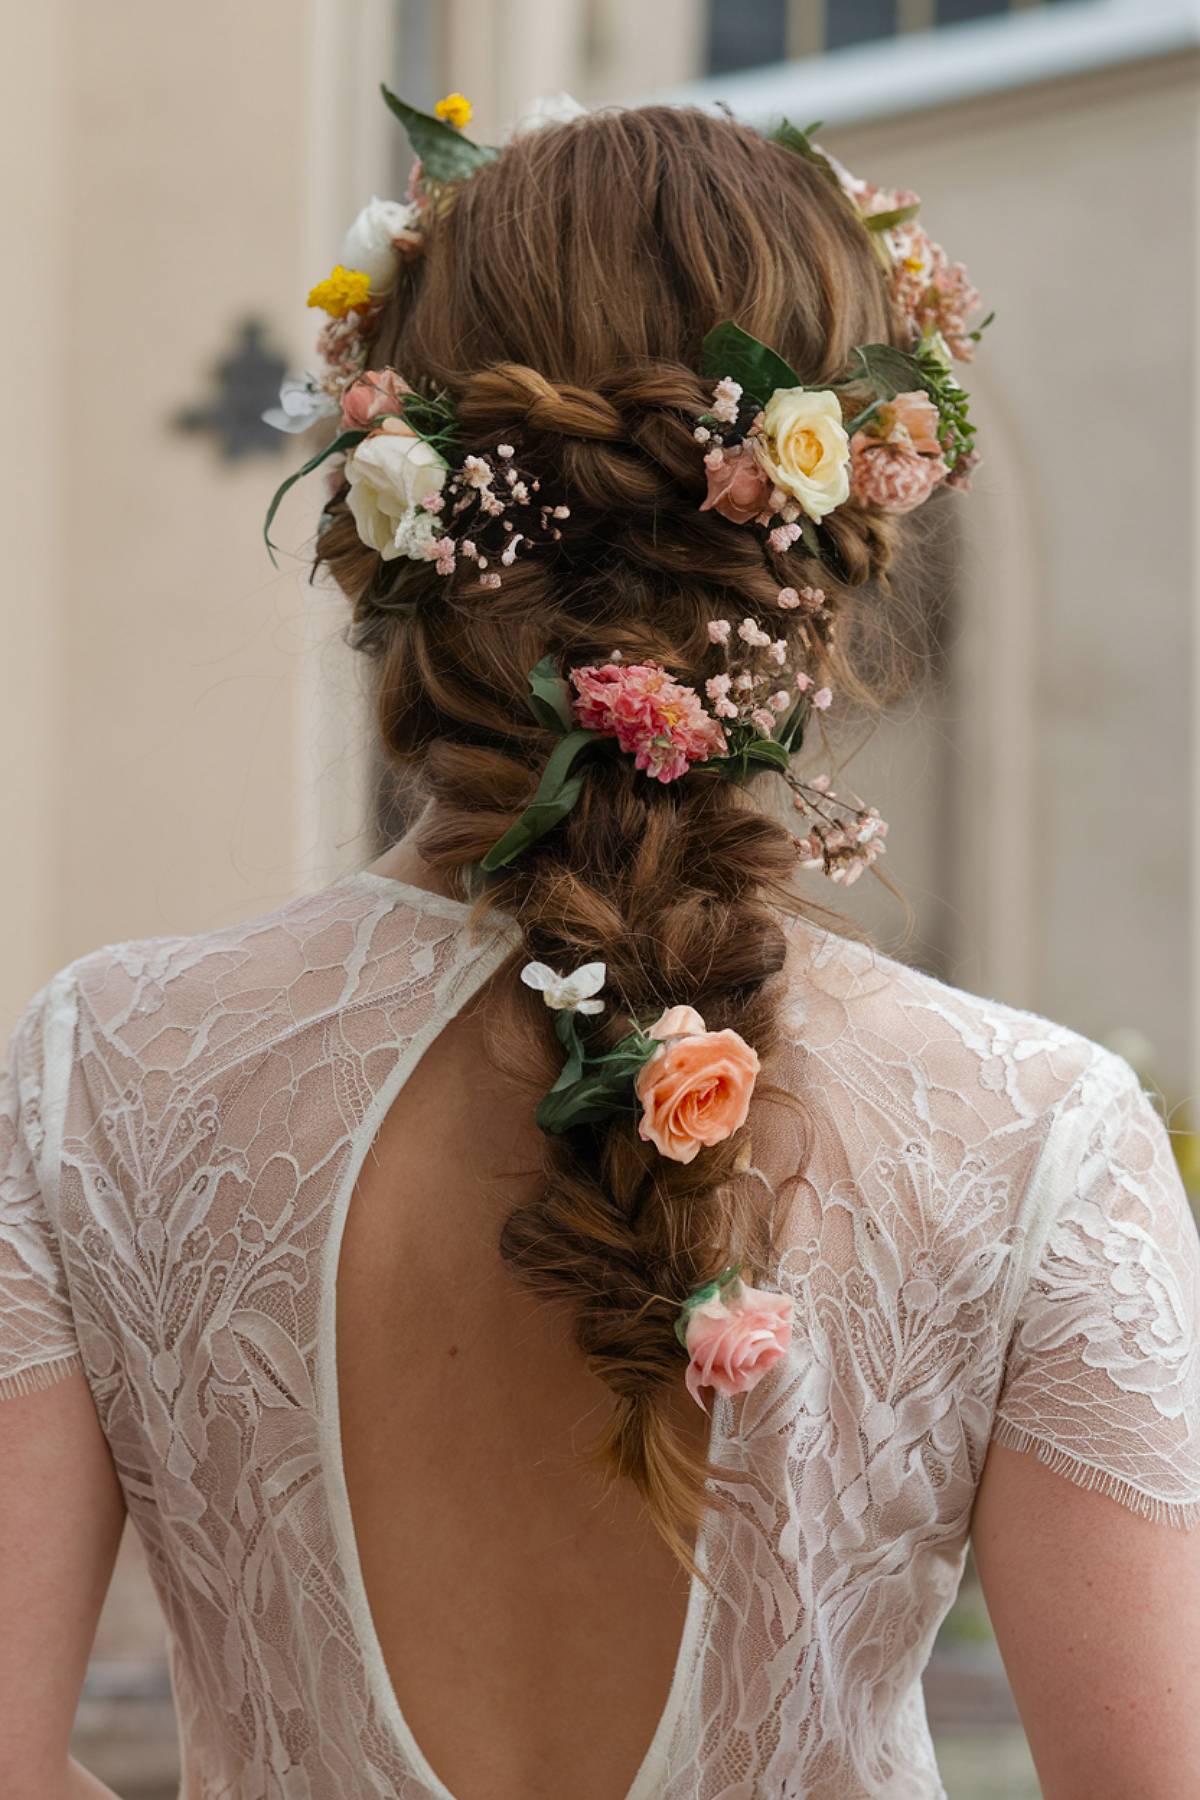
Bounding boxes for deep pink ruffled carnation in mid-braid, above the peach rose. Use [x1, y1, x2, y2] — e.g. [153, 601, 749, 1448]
[570, 662, 727, 781]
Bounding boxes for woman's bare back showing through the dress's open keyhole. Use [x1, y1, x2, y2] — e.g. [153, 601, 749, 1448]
[336, 992, 709, 1800]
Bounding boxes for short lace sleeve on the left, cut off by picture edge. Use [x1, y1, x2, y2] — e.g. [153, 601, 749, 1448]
[0, 977, 81, 1400]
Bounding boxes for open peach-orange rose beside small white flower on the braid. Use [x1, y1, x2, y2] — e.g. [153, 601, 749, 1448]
[637, 1006, 759, 1163]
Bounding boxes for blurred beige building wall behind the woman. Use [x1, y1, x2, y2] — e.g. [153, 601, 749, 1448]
[0, 0, 1200, 1796]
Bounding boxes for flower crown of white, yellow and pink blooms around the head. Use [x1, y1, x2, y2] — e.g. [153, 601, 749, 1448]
[263, 100, 990, 587]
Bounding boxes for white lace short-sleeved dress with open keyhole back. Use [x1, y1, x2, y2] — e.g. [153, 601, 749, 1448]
[0, 873, 1200, 1800]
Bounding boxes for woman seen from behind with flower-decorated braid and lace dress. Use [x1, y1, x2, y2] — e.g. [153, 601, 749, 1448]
[0, 97, 1200, 1800]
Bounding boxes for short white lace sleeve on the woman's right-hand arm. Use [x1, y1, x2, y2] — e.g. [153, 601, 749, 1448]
[993, 1051, 1200, 1528]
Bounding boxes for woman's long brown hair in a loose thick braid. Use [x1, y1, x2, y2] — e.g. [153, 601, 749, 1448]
[318, 106, 903, 1568]
